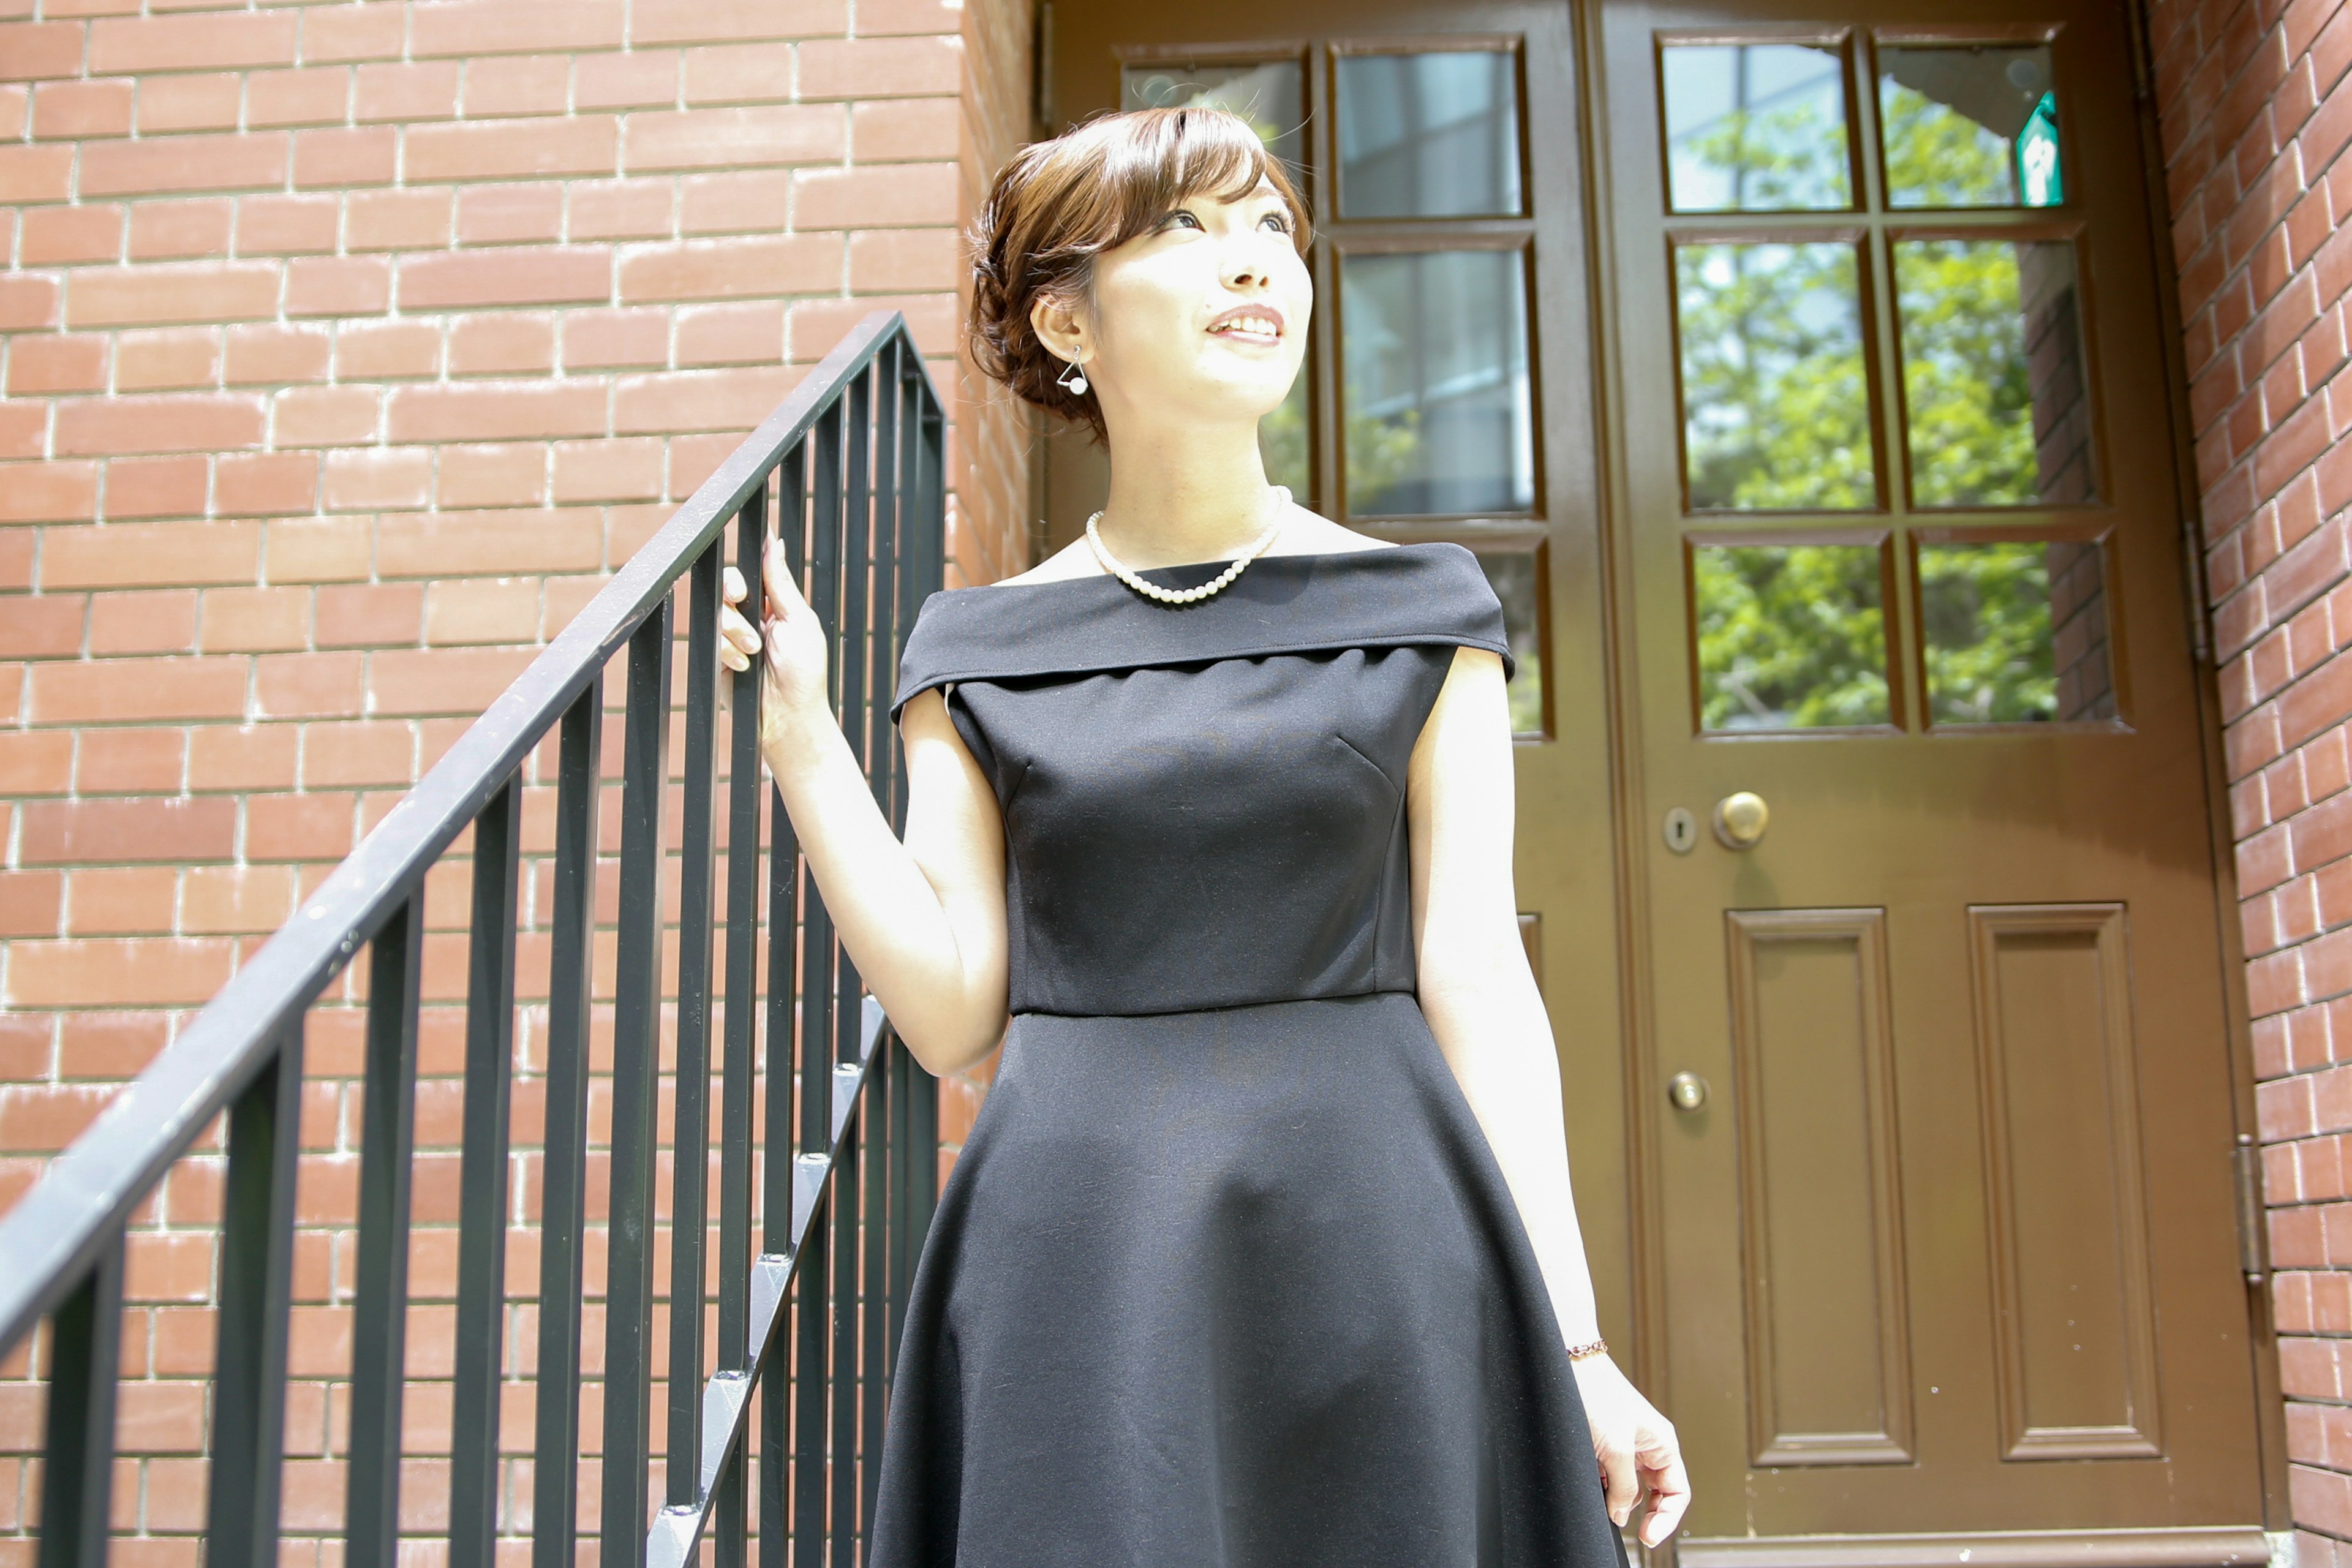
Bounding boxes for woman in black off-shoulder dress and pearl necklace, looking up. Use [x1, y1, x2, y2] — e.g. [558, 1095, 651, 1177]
[706, 108, 1686, 1568]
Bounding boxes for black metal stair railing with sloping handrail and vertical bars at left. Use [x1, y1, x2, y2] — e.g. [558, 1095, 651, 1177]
[0, 312, 946, 1568]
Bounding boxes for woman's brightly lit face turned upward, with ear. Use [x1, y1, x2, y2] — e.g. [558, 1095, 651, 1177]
[1033, 181, 1315, 430]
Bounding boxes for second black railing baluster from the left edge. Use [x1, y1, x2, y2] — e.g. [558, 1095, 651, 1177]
[205, 1020, 303, 1568]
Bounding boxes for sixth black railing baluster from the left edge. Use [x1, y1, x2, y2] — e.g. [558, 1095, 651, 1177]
[600, 600, 673, 1568]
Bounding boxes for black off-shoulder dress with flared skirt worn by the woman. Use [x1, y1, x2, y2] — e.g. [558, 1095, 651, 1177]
[873, 543, 1625, 1568]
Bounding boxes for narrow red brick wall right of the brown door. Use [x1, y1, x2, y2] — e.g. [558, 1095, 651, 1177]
[2147, 0, 2352, 1568]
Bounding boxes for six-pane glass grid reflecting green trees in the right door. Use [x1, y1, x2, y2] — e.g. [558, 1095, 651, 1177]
[1658, 37, 2119, 733]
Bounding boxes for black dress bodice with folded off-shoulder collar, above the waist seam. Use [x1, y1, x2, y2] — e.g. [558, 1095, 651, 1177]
[891, 543, 1510, 1016]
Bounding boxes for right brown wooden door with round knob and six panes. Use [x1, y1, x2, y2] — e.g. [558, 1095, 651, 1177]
[1595, 0, 2263, 1563]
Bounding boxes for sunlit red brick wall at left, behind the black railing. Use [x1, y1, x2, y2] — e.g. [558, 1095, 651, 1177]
[0, 0, 1030, 1563]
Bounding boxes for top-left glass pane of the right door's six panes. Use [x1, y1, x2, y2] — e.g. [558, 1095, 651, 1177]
[1658, 45, 1853, 211]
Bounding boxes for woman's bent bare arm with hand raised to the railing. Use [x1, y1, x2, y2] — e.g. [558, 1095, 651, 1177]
[720, 543, 1007, 1074]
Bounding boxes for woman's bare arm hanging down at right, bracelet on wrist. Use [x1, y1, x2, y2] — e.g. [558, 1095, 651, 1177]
[1406, 649, 1689, 1547]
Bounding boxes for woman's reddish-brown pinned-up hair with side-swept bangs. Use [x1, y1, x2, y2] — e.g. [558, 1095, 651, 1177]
[967, 108, 1315, 440]
